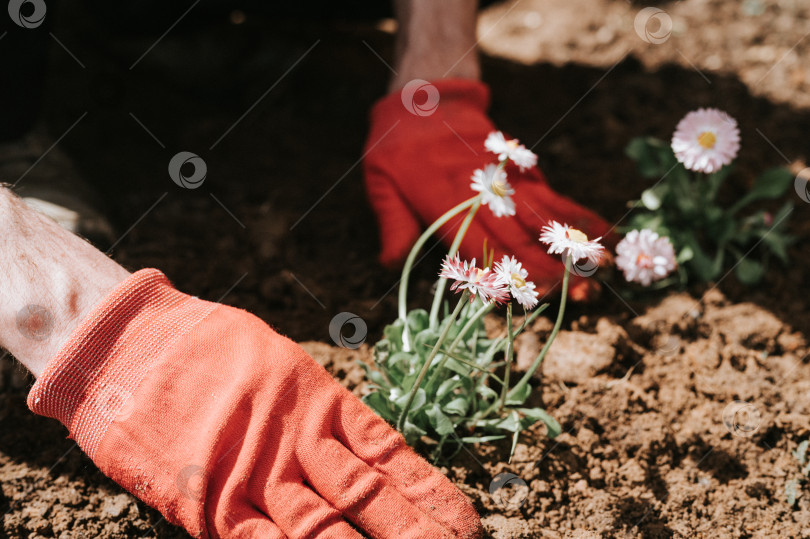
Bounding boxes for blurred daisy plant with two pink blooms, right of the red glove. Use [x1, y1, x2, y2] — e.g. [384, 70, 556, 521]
[616, 108, 794, 286]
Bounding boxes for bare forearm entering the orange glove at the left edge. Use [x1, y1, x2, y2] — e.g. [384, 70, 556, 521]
[0, 186, 129, 377]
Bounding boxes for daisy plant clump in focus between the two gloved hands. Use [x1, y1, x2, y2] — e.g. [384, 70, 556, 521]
[364, 132, 601, 459]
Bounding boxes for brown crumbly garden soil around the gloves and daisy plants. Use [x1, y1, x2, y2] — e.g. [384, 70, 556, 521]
[0, 0, 810, 538]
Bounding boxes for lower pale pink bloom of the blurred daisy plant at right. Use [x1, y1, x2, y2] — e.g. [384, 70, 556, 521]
[616, 229, 677, 286]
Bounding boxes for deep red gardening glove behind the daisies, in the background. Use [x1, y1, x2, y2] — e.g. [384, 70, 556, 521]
[364, 79, 610, 300]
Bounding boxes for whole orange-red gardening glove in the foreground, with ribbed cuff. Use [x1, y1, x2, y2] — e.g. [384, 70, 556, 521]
[28, 270, 481, 539]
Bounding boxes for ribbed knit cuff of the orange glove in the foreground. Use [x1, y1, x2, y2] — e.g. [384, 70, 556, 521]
[28, 269, 216, 459]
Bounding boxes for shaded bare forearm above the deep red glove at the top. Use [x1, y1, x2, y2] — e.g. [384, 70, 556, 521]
[389, 0, 480, 92]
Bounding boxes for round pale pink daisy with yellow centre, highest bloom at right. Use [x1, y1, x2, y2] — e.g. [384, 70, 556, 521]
[672, 109, 740, 174]
